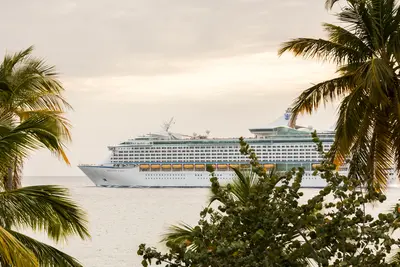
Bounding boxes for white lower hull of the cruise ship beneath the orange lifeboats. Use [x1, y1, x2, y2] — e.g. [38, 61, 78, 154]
[79, 166, 397, 188]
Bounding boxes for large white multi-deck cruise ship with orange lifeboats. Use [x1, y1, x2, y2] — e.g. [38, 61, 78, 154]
[79, 109, 395, 188]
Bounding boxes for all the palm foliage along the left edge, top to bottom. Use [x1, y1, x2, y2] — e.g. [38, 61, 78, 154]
[0, 50, 90, 267]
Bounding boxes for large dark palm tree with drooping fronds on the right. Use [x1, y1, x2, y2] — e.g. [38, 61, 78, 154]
[279, 0, 400, 190]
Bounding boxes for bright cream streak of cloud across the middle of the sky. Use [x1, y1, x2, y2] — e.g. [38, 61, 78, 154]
[66, 53, 334, 103]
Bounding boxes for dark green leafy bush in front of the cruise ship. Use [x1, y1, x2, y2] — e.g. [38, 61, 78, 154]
[138, 133, 400, 267]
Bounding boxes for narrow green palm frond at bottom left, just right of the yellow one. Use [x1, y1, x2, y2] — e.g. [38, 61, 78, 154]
[8, 230, 82, 267]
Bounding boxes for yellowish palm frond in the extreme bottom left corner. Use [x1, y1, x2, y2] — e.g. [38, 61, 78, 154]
[0, 226, 39, 267]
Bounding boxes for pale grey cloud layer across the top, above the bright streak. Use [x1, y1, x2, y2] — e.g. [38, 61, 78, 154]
[0, 0, 328, 77]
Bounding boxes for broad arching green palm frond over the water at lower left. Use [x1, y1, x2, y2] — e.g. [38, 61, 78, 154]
[0, 185, 90, 241]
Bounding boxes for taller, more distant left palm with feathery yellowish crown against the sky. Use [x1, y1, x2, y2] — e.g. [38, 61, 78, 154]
[0, 47, 71, 190]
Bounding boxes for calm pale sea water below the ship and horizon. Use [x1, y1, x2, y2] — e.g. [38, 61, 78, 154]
[23, 177, 400, 267]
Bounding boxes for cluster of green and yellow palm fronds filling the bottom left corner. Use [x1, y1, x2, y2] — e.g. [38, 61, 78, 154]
[0, 185, 90, 267]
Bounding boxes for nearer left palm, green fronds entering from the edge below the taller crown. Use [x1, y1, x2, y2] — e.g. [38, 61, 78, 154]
[0, 112, 90, 267]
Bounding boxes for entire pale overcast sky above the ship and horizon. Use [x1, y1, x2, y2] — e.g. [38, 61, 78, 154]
[0, 0, 342, 176]
